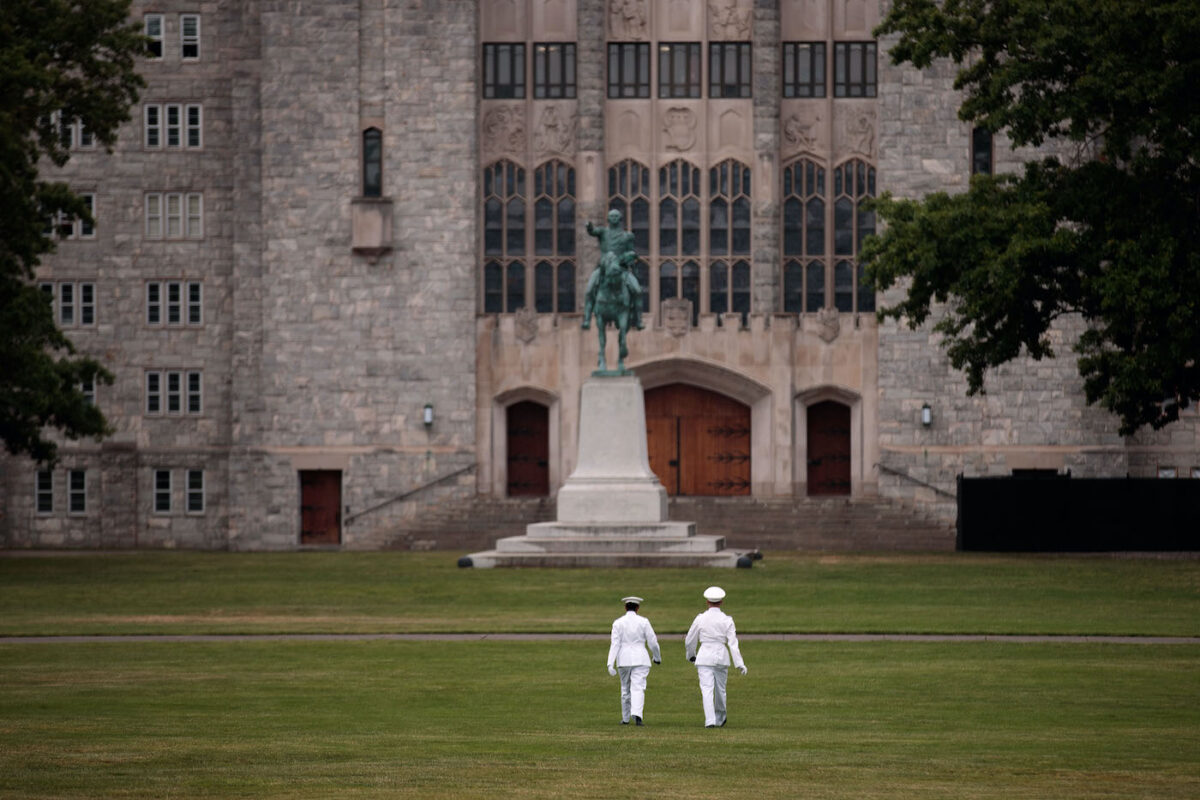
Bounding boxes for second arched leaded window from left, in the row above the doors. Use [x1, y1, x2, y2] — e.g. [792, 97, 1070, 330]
[533, 161, 575, 313]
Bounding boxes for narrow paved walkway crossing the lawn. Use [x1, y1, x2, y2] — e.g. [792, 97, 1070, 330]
[0, 633, 1200, 645]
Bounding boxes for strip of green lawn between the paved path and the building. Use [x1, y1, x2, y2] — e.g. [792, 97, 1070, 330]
[0, 553, 1200, 636]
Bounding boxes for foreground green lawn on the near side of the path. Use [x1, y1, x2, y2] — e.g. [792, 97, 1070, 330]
[0, 640, 1200, 800]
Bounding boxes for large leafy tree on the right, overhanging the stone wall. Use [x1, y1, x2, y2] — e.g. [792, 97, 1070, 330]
[864, 0, 1200, 435]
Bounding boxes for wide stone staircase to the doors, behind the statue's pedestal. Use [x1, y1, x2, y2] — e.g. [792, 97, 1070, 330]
[356, 497, 955, 552]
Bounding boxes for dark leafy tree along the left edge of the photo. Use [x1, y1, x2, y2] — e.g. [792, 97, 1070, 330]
[0, 0, 145, 463]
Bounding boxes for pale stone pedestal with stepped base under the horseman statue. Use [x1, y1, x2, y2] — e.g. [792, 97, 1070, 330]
[458, 375, 751, 567]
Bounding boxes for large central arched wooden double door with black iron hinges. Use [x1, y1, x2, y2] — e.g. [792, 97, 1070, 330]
[646, 384, 750, 495]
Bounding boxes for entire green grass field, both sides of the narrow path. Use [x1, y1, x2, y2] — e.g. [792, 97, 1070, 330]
[0, 553, 1200, 799]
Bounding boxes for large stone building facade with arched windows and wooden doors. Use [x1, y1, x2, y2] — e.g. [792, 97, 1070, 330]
[0, 0, 1200, 549]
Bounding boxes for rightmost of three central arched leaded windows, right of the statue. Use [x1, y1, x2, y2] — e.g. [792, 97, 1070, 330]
[708, 160, 750, 324]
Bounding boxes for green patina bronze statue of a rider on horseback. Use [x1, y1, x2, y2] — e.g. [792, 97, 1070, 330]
[583, 209, 646, 375]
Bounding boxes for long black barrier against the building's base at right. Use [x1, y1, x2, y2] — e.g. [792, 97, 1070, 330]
[958, 475, 1200, 553]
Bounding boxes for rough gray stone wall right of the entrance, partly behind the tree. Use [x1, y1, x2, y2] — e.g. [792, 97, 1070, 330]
[878, 31, 1200, 518]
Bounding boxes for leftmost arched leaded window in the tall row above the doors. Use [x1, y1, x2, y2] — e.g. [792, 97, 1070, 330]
[484, 161, 527, 314]
